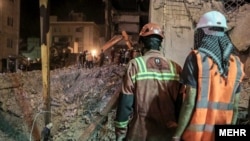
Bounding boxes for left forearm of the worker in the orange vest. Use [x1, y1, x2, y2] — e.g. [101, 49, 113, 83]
[173, 86, 196, 141]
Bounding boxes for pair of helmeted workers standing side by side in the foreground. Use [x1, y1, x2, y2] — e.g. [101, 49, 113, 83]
[114, 11, 244, 141]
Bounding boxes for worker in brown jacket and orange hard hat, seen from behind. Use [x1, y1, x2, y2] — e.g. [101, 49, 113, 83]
[115, 23, 181, 141]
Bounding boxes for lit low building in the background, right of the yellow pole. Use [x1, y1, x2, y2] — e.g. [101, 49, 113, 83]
[50, 17, 101, 53]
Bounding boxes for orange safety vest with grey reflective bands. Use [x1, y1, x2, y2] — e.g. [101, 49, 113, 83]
[182, 51, 244, 141]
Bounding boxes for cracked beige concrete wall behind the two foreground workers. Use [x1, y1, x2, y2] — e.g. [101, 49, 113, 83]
[149, 0, 250, 75]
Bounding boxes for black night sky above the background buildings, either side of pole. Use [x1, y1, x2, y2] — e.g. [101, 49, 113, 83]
[20, 0, 105, 39]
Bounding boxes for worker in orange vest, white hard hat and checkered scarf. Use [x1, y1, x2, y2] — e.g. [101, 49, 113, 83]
[173, 11, 244, 141]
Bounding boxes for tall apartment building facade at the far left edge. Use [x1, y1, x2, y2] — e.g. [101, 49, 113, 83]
[0, 0, 21, 72]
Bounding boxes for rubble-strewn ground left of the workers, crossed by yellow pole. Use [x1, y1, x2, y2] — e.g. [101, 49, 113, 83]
[0, 65, 125, 141]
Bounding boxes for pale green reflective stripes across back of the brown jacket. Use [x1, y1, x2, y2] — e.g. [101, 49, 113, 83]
[132, 57, 179, 83]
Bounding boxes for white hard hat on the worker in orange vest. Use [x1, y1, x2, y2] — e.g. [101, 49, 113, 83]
[196, 11, 227, 31]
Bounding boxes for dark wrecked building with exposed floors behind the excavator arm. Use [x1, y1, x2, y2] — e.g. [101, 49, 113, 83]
[104, 0, 149, 49]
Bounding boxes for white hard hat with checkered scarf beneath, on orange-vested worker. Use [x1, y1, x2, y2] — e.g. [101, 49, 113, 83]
[194, 11, 234, 77]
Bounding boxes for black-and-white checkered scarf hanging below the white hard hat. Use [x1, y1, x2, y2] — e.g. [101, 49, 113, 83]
[194, 29, 234, 77]
